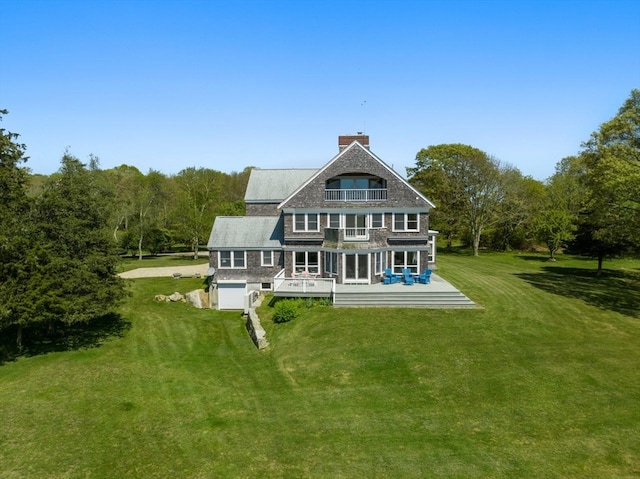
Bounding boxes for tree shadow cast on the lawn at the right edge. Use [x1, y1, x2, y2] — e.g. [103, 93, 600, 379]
[516, 265, 640, 318]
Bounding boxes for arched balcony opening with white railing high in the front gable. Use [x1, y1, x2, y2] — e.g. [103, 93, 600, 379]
[325, 173, 387, 201]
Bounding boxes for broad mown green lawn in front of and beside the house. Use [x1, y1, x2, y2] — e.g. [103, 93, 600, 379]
[0, 254, 640, 478]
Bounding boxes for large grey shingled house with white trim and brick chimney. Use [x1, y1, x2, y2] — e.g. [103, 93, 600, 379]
[208, 135, 436, 309]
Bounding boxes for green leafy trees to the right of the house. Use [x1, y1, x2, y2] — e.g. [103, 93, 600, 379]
[407, 89, 640, 274]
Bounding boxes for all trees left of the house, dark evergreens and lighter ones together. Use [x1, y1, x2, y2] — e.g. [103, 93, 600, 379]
[0, 110, 251, 352]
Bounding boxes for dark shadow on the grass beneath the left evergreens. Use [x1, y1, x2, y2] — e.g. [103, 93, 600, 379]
[0, 313, 131, 365]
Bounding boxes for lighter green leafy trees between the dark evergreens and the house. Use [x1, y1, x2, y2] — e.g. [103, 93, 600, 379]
[27, 160, 251, 259]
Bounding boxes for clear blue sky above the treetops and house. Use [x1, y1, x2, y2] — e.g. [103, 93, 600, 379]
[0, 0, 640, 180]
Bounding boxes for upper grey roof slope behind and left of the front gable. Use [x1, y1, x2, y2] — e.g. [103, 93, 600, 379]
[244, 168, 318, 203]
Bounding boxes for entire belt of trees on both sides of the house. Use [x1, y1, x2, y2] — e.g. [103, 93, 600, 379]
[0, 90, 640, 352]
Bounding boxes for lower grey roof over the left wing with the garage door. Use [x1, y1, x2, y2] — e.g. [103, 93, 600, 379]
[207, 216, 284, 250]
